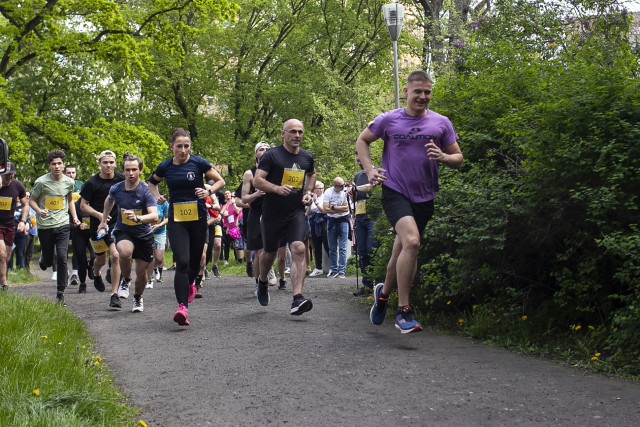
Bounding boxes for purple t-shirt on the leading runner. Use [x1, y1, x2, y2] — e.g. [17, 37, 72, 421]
[369, 108, 458, 203]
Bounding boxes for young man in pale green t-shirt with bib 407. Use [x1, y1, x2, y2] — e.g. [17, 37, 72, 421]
[29, 150, 80, 304]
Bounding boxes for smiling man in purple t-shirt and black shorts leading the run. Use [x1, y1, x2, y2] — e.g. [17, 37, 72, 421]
[356, 70, 462, 334]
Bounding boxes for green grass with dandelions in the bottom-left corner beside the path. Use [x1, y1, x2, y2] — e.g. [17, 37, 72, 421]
[0, 292, 138, 426]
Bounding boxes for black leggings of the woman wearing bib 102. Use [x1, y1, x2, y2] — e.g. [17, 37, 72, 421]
[167, 218, 207, 307]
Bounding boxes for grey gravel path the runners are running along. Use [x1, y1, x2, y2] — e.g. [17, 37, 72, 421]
[11, 271, 640, 427]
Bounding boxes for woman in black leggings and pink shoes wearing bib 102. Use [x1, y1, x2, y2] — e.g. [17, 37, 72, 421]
[149, 128, 224, 326]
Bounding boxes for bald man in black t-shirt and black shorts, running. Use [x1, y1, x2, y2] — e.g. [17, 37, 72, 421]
[253, 119, 316, 315]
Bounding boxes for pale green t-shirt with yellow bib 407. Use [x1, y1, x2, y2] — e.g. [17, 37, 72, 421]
[31, 173, 74, 230]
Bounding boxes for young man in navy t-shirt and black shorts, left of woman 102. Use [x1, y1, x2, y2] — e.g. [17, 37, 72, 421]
[98, 154, 158, 313]
